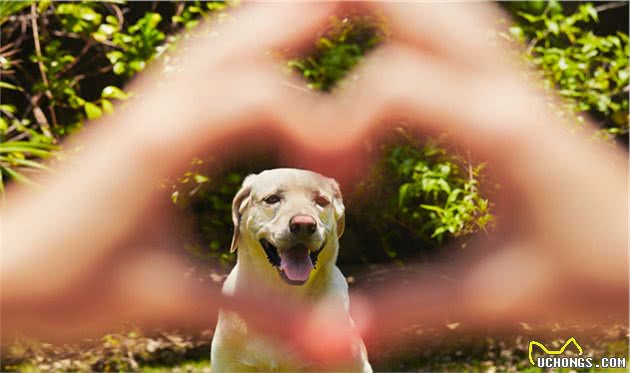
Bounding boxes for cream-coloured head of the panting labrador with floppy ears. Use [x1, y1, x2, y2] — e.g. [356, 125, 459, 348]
[231, 168, 344, 285]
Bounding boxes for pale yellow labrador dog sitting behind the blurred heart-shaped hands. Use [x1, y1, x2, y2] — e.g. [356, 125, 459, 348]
[212, 168, 372, 373]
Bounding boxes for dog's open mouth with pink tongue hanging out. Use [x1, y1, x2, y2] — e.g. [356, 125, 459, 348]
[260, 238, 326, 285]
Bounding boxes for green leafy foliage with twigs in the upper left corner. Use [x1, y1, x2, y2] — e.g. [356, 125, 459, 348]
[0, 0, 227, 194]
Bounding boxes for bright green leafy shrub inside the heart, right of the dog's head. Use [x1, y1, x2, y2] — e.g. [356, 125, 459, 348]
[387, 140, 492, 242]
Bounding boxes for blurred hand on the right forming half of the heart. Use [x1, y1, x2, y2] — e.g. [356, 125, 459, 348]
[298, 3, 628, 347]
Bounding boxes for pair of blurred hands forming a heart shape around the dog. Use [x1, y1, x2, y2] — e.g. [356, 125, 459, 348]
[3, 3, 627, 368]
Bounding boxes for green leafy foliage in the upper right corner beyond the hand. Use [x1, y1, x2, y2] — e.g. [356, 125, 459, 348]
[509, 1, 630, 136]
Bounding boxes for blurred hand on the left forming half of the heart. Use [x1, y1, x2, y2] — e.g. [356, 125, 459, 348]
[2, 0, 334, 341]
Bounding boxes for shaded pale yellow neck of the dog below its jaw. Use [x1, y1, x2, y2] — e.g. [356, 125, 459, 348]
[235, 238, 338, 297]
